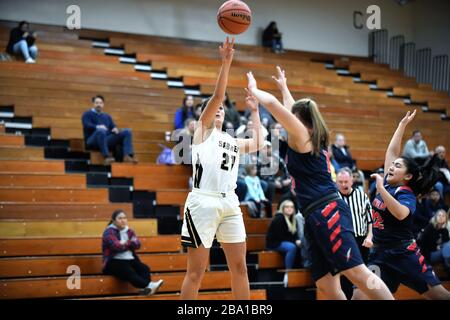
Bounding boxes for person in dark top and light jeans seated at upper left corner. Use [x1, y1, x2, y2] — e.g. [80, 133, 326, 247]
[6, 21, 38, 63]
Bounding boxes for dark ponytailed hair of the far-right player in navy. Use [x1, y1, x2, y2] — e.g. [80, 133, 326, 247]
[401, 157, 439, 196]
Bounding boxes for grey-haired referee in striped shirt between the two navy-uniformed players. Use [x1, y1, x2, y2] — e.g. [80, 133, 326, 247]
[336, 167, 373, 264]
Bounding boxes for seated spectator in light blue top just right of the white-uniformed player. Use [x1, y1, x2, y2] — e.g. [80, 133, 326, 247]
[245, 164, 268, 218]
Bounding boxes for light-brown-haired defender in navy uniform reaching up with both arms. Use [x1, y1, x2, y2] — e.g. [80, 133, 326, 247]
[247, 67, 393, 300]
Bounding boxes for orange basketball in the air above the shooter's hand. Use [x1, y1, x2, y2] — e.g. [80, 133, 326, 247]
[217, 0, 252, 34]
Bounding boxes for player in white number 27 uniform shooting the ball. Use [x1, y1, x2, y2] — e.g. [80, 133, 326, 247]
[180, 38, 264, 300]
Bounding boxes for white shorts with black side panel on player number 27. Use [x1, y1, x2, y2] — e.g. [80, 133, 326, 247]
[181, 189, 247, 248]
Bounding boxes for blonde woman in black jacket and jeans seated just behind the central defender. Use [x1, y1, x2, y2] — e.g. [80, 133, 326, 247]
[266, 200, 301, 269]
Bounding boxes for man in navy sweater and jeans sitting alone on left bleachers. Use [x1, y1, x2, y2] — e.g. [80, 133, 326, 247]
[81, 95, 137, 165]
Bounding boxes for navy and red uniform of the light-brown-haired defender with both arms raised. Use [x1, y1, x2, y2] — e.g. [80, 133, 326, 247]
[287, 148, 363, 281]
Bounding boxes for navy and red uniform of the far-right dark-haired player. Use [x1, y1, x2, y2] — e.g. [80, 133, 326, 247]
[368, 180, 440, 294]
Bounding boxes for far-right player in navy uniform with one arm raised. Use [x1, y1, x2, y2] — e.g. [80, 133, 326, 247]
[353, 111, 450, 299]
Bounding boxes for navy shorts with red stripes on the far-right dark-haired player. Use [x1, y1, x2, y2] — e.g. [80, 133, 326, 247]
[368, 241, 441, 294]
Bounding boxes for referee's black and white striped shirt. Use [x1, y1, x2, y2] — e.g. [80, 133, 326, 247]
[339, 188, 373, 237]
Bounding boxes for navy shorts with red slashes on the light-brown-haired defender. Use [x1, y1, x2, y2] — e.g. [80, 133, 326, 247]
[305, 199, 364, 281]
